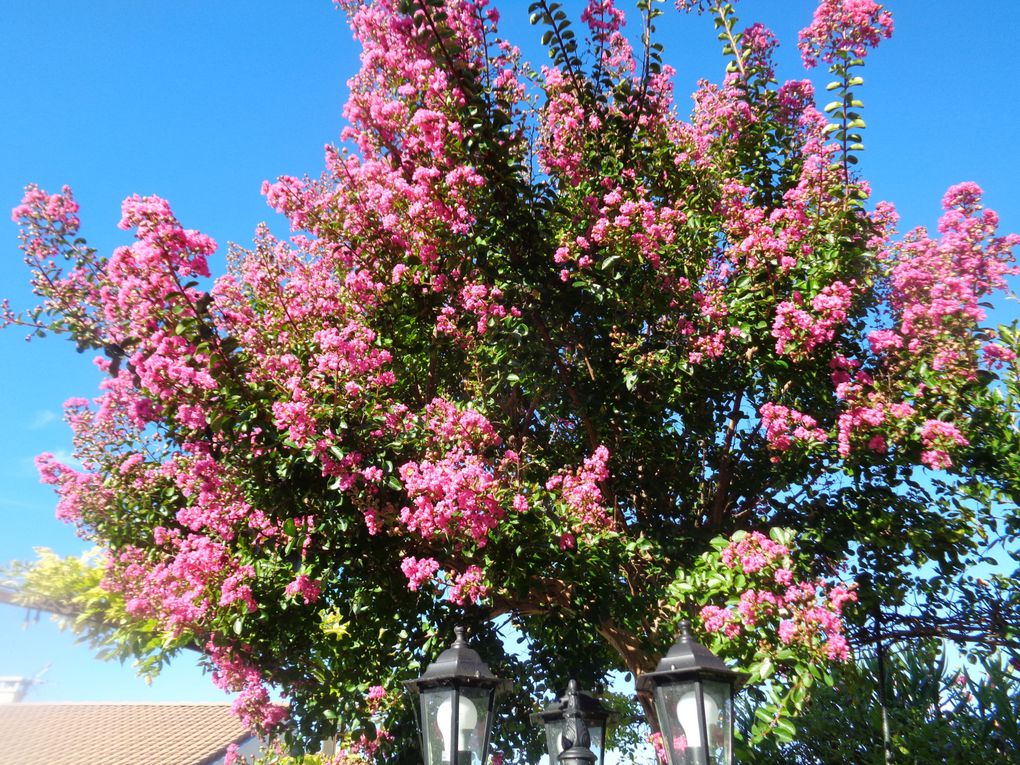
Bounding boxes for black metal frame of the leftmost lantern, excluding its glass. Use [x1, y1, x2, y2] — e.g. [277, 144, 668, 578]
[404, 626, 510, 765]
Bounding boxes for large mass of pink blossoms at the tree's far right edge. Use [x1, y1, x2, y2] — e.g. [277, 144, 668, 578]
[831, 183, 1020, 469]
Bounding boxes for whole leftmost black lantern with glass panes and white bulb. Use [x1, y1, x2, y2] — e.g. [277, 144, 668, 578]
[404, 627, 507, 765]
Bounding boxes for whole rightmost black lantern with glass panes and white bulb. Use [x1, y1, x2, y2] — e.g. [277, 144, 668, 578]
[638, 619, 746, 765]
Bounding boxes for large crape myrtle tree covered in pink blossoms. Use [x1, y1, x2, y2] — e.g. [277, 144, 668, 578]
[6, 0, 1020, 759]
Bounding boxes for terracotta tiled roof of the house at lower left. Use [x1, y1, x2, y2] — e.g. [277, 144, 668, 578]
[0, 703, 252, 765]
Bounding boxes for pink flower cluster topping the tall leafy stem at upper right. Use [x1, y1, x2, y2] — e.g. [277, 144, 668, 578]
[799, 0, 893, 68]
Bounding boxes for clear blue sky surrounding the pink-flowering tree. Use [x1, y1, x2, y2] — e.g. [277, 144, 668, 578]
[0, 0, 1020, 701]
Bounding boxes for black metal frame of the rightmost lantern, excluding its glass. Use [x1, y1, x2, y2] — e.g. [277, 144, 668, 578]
[636, 619, 748, 765]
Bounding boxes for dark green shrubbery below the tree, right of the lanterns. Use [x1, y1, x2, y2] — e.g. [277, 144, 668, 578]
[741, 642, 1020, 765]
